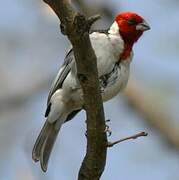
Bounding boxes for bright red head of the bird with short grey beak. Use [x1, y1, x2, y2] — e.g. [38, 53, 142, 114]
[115, 12, 150, 45]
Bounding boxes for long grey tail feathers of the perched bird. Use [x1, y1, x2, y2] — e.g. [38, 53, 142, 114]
[32, 120, 60, 172]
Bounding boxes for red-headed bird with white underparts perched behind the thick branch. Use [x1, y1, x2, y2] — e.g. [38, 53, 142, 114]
[32, 12, 150, 172]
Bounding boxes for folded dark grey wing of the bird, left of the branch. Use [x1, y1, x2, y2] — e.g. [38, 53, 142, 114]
[47, 49, 74, 106]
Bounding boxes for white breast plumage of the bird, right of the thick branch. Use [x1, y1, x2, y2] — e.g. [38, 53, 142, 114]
[90, 28, 132, 101]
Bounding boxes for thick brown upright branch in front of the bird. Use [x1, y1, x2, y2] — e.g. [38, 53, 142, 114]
[44, 0, 107, 180]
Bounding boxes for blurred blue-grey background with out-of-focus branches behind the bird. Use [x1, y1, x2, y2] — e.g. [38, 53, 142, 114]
[0, 0, 179, 180]
